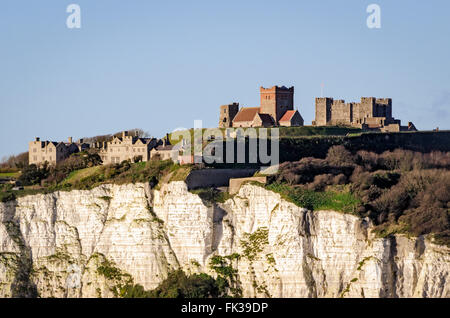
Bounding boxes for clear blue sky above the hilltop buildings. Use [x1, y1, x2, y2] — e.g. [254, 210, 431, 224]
[0, 0, 450, 157]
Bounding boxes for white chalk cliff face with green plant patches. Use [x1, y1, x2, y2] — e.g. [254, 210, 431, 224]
[0, 182, 450, 297]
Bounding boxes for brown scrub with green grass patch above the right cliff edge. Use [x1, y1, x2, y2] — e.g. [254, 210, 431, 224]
[266, 146, 450, 245]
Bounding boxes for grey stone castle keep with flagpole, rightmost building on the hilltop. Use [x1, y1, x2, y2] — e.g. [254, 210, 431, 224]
[312, 97, 417, 132]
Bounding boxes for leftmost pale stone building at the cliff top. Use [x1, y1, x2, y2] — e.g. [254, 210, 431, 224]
[28, 137, 89, 165]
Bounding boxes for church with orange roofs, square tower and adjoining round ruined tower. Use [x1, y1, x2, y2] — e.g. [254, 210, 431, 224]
[219, 86, 303, 128]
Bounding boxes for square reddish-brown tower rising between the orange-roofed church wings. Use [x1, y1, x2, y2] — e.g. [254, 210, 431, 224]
[260, 86, 294, 124]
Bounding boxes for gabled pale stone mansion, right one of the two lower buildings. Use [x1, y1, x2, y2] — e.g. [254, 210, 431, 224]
[96, 131, 157, 164]
